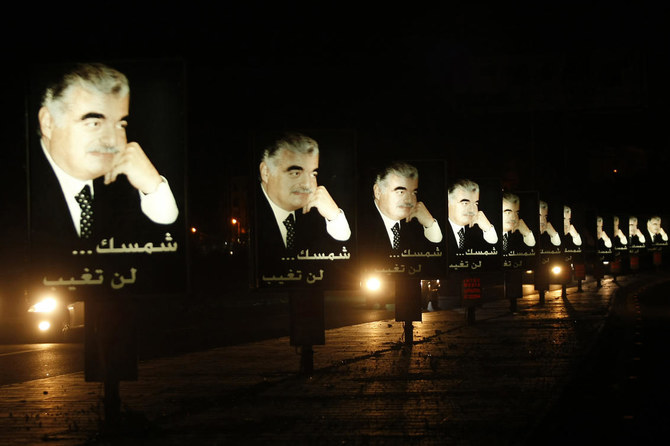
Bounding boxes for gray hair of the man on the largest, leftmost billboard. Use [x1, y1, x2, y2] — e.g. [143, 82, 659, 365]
[42, 63, 130, 125]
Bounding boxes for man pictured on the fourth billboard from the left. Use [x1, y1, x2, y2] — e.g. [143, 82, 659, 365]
[447, 179, 499, 253]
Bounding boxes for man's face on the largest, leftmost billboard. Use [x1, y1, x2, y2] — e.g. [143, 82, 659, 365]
[40, 87, 129, 180]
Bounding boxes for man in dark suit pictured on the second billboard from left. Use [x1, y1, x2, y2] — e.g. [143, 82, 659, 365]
[256, 132, 351, 282]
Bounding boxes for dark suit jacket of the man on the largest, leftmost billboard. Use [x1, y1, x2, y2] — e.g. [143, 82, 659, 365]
[30, 147, 175, 296]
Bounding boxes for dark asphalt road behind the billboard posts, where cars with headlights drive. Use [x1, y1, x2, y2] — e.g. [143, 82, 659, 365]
[0, 297, 394, 385]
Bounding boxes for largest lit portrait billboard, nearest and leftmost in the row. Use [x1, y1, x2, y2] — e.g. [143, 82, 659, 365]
[27, 61, 186, 299]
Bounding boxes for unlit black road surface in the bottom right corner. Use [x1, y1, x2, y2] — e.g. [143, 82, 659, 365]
[534, 283, 670, 445]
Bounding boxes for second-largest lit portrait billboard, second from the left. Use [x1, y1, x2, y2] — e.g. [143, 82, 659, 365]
[251, 130, 355, 289]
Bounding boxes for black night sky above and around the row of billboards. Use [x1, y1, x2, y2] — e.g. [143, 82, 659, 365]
[0, 1, 670, 296]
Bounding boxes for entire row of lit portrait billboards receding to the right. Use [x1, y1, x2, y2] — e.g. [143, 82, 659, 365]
[26, 61, 668, 299]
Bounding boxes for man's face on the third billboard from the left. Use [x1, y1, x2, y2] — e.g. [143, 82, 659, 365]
[373, 173, 419, 220]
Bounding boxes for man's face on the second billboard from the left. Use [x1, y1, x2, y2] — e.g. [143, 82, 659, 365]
[260, 149, 319, 212]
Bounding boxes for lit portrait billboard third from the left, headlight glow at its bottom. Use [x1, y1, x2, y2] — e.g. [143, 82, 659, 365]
[356, 160, 446, 279]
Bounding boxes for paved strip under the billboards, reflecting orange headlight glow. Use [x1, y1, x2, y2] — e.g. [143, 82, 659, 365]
[0, 273, 670, 445]
